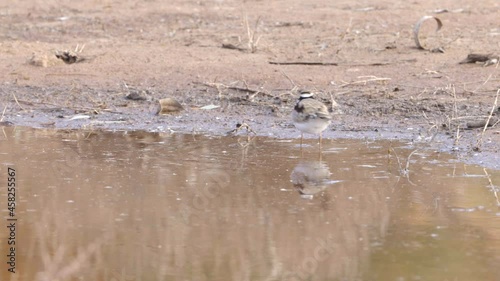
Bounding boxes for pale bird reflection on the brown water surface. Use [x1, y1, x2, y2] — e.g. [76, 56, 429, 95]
[290, 161, 340, 199]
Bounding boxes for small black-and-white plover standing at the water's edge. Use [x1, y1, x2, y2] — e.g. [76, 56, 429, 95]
[292, 91, 332, 147]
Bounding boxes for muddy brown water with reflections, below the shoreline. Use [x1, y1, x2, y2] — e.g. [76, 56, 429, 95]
[0, 128, 500, 281]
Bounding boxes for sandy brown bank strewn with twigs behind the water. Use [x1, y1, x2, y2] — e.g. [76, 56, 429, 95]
[0, 0, 500, 169]
